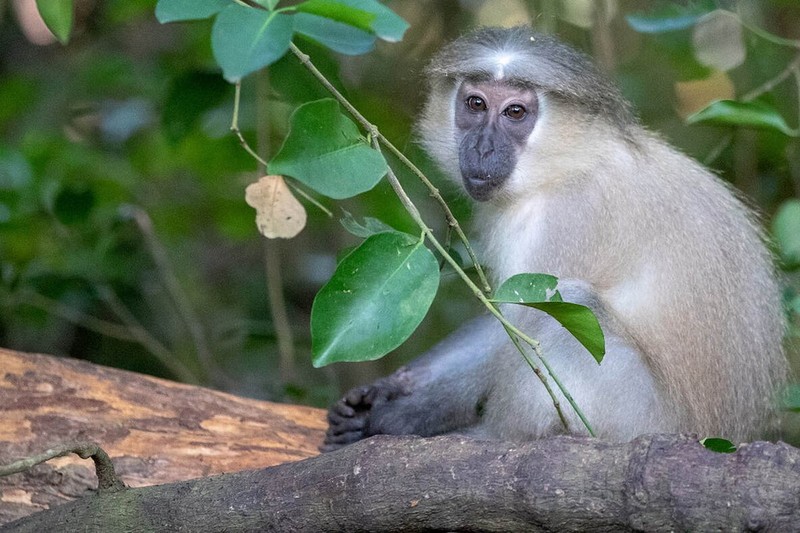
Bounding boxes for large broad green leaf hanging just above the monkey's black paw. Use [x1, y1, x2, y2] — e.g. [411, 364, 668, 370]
[311, 232, 439, 367]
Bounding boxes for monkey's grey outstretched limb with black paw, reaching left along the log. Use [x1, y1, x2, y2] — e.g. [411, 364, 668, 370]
[321, 316, 503, 451]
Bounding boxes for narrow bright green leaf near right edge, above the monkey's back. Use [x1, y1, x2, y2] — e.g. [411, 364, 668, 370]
[686, 100, 798, 137]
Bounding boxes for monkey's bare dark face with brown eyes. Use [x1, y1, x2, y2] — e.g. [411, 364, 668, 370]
[455, 81, 539, 201]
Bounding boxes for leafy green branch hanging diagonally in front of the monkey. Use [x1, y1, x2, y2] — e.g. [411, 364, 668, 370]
[156, 0, 605, 435]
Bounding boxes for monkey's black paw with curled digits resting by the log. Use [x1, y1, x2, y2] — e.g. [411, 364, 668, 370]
[320, 367, 413, 452]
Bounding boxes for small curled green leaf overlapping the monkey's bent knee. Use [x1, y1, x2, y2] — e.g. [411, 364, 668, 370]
[492, 274, 606, 363]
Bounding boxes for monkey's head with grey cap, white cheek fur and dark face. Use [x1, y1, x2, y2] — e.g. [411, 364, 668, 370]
[419, 27, 635, 201]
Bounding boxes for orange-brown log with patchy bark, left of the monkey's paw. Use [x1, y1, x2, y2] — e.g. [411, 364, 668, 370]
[0, 349, 327, 525]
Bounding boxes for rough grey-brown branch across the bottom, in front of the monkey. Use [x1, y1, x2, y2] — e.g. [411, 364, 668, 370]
[8, 435, 800, 533]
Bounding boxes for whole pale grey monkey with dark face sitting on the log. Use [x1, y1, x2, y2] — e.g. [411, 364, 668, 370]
[321, 27, 787, 451]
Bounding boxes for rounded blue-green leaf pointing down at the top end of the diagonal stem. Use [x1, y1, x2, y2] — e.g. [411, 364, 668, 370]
[211, 4, 294, 83]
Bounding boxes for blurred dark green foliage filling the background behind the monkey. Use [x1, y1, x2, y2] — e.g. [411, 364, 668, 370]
[0, 0, 800, 430]
